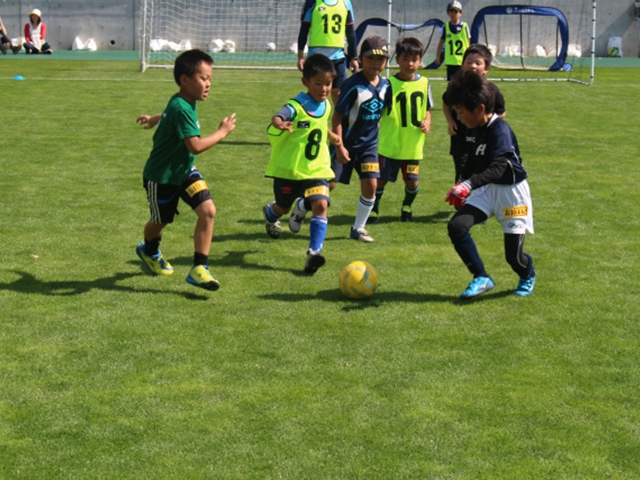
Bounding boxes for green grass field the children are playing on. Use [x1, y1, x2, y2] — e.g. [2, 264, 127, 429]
[0, 61, 640, 480]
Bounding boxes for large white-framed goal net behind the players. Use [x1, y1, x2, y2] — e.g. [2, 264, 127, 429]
[140, 0, 596, 83]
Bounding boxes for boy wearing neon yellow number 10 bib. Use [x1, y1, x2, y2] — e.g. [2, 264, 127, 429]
[368, 37, 433, 223]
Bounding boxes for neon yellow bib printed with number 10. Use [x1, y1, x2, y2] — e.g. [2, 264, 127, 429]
[378, 76, 432, 160]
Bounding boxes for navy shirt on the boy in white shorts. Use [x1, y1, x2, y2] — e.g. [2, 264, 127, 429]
[463, 114, 527, 188]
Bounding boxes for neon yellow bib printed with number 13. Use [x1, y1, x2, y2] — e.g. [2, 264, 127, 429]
[309, 0, 349, 48]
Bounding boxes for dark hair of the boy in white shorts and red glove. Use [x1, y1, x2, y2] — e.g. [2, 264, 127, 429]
[445, 70, 496, 113]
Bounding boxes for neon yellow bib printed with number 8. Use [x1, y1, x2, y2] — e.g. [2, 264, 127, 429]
[265, 94, 335, 180]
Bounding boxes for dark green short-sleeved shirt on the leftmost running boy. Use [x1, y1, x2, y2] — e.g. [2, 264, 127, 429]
[143, 93, 200, 185]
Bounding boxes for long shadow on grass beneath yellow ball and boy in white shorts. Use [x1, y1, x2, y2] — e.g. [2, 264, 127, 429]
[258, 288, 513, 311]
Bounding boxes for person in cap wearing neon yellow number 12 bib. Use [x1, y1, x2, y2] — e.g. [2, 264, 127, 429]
[436, 0, 471, 80]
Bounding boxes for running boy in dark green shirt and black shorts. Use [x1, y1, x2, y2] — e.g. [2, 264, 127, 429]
[136, 50, 236, 290]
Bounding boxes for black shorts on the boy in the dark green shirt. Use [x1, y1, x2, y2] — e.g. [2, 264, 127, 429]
[143, 167, 212, 224]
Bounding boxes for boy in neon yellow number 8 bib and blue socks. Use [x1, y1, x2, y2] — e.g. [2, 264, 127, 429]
[262, 53, 339, 274]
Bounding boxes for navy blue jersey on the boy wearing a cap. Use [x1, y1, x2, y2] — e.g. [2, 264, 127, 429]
[336, 72, 391, 153]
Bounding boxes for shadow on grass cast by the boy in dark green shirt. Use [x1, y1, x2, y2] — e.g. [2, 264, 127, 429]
[0, 270, 209, 300]
